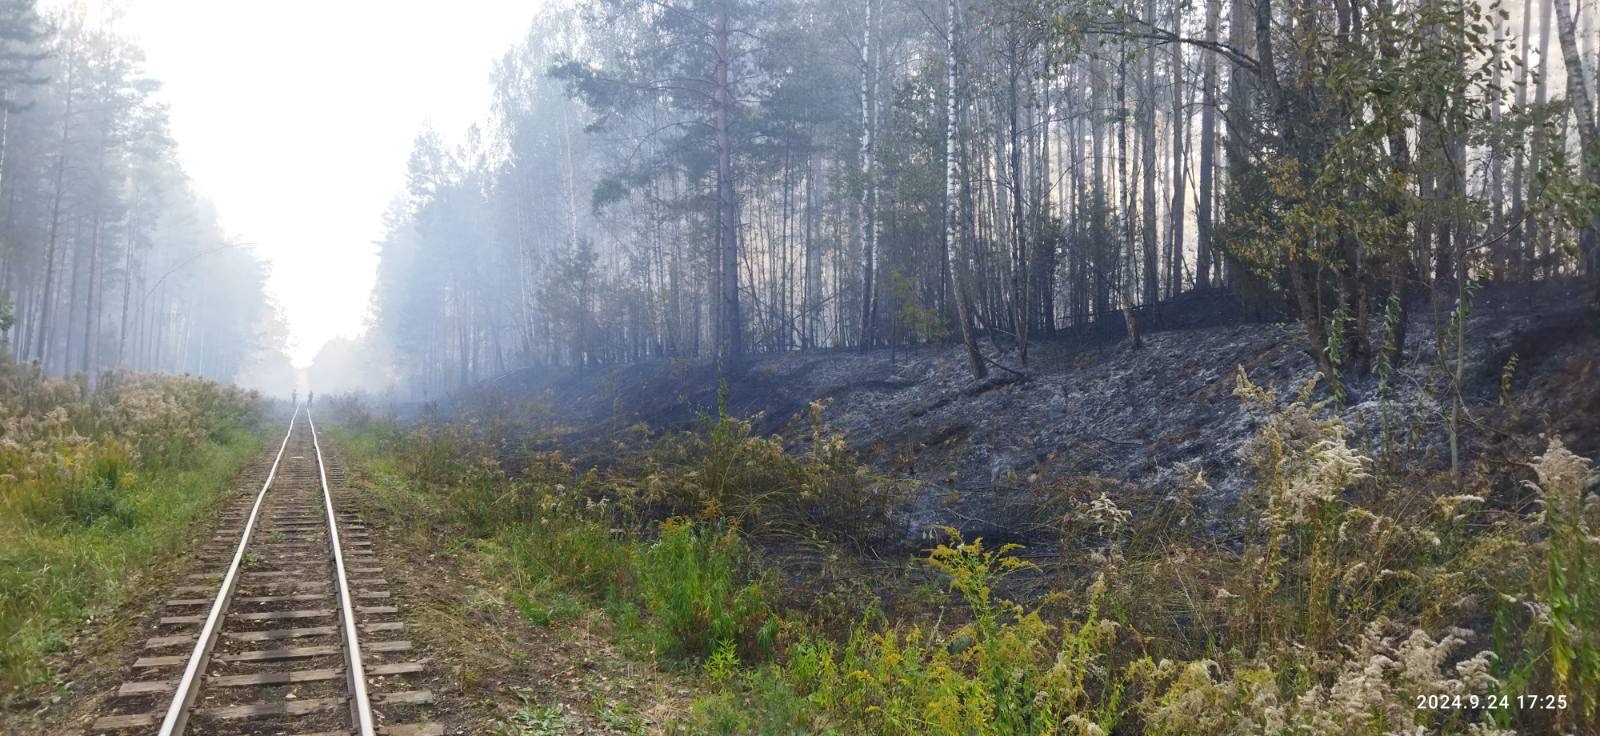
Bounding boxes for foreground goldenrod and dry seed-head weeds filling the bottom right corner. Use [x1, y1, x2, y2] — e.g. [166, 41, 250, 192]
[678, 371, 1600, 736]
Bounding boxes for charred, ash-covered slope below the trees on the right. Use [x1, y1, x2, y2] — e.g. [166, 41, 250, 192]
[458, 284, 1600, 539]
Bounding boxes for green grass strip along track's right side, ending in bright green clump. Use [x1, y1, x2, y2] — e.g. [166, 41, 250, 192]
[331, 421, 776, 669]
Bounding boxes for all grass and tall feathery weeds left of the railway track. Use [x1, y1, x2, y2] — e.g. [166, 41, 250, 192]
[0, 363, 261, 693]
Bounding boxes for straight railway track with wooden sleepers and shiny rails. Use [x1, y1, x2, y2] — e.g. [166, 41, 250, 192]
[91, 406, 443, 736]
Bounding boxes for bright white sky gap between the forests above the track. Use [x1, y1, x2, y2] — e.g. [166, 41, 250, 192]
[51, 0, 541, 366]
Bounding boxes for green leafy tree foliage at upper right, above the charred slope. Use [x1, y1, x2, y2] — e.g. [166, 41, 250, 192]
[1221, 3, 1523, 379]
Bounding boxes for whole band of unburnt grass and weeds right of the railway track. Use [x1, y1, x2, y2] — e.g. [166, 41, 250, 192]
[324, 390, 1600, 736]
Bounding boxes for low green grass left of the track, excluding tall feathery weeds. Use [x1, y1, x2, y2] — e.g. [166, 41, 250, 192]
[0, 422, 261, 698]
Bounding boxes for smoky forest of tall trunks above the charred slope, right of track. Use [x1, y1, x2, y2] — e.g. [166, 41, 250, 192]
[334, 0, 1600, 397]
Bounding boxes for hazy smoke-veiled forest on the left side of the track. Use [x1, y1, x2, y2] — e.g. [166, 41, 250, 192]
[0, 0, 283, 390]
